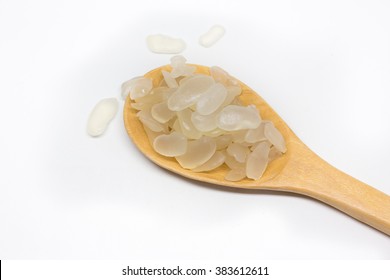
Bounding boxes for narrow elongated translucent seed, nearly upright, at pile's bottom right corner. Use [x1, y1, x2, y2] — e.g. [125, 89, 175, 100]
[245, 142, 270, 180]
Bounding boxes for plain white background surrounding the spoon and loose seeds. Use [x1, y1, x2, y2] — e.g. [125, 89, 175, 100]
[0, 0, 390, 260]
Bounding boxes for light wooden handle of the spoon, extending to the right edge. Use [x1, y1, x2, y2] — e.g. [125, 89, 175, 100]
[272, 144, 390, 235]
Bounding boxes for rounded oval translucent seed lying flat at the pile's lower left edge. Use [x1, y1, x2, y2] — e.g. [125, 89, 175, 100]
[153, 131, 187, 157]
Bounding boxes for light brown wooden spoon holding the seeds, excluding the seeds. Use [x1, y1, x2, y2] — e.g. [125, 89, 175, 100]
[124, 65, 390, 235]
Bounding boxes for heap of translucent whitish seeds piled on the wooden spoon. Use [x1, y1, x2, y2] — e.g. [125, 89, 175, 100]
[122, 56, 286, 181]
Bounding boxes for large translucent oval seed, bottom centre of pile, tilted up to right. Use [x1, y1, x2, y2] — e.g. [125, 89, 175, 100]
[176, 136, 216, 169]
